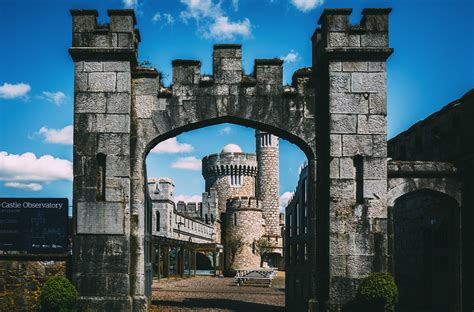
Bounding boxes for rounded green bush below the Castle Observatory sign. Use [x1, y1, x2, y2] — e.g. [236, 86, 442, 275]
[40, 276, 78, 312]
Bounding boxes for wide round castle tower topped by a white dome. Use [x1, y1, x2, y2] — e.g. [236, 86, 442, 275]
[202, 144, 257, 214]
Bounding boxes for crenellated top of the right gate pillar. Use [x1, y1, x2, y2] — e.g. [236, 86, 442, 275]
[312, 8, 392, 58]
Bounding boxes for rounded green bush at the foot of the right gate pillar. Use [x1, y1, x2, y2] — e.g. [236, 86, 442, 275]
[357, 272, 398, 311]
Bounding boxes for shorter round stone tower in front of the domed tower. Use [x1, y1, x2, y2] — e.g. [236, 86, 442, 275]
[225, 197, 265, 270]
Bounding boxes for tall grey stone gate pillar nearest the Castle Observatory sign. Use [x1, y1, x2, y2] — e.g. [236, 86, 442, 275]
[69, 10, 139, 311]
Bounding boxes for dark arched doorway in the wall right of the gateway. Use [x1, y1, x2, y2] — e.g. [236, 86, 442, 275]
[392, 189, 460, 312]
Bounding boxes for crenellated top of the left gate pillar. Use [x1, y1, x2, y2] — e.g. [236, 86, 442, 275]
[69, 10, 140, 63]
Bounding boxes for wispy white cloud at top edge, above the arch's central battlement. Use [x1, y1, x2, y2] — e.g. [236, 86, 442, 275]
[180, 0, 252, 40]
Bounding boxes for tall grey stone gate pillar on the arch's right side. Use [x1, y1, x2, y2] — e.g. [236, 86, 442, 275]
[313, 9, 392, 311]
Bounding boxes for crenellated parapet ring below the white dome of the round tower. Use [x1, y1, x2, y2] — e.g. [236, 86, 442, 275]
[202, 153, 257, 178]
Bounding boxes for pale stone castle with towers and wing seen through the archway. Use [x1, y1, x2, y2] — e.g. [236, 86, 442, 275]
[148, 130, 283, 270]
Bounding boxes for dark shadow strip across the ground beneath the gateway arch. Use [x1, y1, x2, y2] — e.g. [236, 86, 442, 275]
[151, 298, 285, 312]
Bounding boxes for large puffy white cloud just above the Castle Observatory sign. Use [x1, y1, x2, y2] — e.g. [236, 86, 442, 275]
[0, 152, 73, 182]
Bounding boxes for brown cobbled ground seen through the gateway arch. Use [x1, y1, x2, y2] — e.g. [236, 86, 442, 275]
[149, 273, 285, 312]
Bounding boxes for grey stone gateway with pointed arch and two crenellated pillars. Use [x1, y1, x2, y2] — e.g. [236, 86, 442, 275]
[69, 9, 470, 311]
